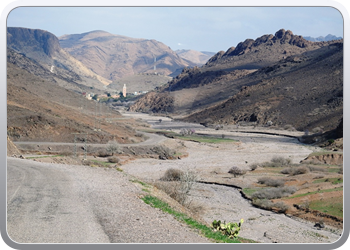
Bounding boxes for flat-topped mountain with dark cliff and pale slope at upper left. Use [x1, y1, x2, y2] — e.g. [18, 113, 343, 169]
[7, 27, 111, 92]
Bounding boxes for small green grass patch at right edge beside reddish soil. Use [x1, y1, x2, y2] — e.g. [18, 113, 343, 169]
[310, 197, 343, 218]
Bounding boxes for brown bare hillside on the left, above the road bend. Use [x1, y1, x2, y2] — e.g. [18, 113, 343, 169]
[7, 49, 140, 145]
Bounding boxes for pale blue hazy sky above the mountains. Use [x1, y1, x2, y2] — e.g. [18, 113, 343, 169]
[7, 7, 343, 52]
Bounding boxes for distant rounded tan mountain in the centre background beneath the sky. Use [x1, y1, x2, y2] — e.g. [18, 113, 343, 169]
[59, 31, 193, 81]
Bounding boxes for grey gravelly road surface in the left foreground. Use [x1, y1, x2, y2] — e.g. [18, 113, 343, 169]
[7, 158, 209, 243]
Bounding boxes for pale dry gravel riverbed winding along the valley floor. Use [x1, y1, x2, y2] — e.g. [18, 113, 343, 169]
[122, 114, 341, 243]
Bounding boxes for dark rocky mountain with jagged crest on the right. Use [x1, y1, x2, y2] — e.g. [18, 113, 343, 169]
[130, 29, 343, 134]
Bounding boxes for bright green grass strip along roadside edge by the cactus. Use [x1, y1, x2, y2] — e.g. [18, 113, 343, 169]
[141, 195, 254, 243]
